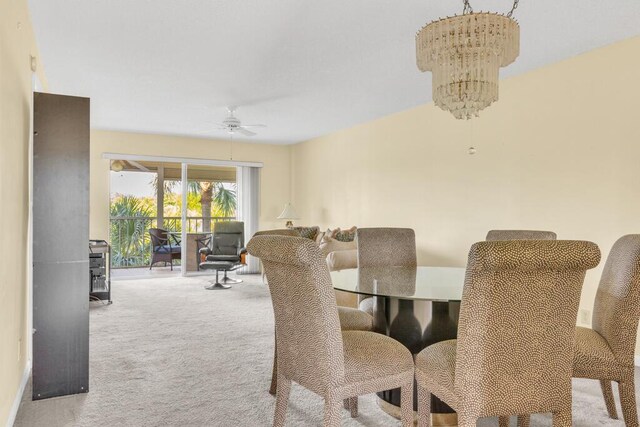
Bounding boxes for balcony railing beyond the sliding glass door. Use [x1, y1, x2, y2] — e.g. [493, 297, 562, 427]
[109, 216, 235, 268]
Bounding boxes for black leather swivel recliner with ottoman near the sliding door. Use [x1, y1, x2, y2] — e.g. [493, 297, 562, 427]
[200, 221, 247, 290]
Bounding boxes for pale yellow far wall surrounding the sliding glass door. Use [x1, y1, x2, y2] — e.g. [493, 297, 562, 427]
[90, 130, 291, 239]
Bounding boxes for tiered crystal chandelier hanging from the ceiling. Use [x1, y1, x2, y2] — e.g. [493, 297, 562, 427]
[416, 0, 520, 119]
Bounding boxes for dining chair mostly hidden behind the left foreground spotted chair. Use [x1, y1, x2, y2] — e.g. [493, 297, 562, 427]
[253, 228, 373, 406]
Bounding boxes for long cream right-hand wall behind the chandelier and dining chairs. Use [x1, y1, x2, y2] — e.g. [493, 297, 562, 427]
[292, 37, 640, 352]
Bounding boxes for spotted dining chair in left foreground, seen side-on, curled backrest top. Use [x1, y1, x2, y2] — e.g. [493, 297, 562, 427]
[247, 236, 413, 427]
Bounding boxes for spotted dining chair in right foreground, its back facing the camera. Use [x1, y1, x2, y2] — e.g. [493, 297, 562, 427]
[416, 240, 600, 427]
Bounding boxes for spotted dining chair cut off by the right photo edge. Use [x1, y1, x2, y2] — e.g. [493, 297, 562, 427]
[573, 234, 640, 427]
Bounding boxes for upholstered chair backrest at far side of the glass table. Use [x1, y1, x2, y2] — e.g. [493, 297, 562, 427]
[356, 228, 418, 267]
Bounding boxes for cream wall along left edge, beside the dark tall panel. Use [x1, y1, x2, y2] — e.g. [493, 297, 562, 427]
[0, 0, 44, 425]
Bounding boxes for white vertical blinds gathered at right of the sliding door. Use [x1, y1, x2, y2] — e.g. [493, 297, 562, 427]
[236, 166, 260, 274]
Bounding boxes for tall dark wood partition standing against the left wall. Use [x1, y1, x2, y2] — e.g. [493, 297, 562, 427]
[33, 93, 89, 399]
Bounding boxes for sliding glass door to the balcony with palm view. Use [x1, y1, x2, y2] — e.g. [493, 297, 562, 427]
[107, 155, 261, 277]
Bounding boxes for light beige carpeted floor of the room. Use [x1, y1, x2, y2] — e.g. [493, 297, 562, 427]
[15, 276, 636, 427]
